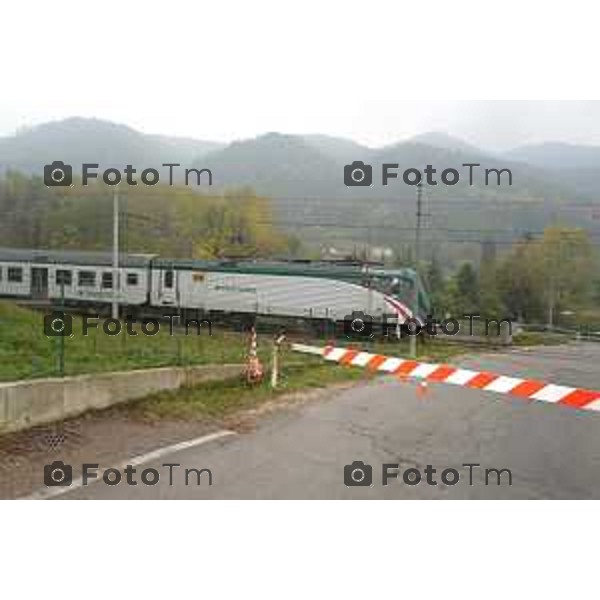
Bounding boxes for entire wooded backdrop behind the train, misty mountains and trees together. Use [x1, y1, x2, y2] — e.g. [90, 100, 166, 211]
[0, 119, 600, 322]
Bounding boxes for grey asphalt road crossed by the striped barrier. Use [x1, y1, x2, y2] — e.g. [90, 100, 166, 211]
[61, 344, 600, 499]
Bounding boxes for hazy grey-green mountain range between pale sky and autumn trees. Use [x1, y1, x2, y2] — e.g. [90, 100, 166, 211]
[0, 118, 600, 258]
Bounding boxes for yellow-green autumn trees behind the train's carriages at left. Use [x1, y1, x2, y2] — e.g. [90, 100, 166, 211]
[0, 172, 290, 258]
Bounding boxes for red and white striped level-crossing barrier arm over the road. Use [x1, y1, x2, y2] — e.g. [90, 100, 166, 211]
[292, 344, 600, 411]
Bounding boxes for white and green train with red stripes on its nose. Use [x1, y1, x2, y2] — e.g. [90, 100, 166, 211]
[0, 248, 429, 332]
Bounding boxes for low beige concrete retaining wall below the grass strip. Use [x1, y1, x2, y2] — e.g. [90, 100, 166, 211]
[0, 365, 243, 433]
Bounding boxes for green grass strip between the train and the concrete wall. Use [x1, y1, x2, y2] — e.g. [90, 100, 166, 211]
[0, 301, 255, 381]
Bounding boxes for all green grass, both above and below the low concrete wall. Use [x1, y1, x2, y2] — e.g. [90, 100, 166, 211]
[0, 302, 496, 422]
